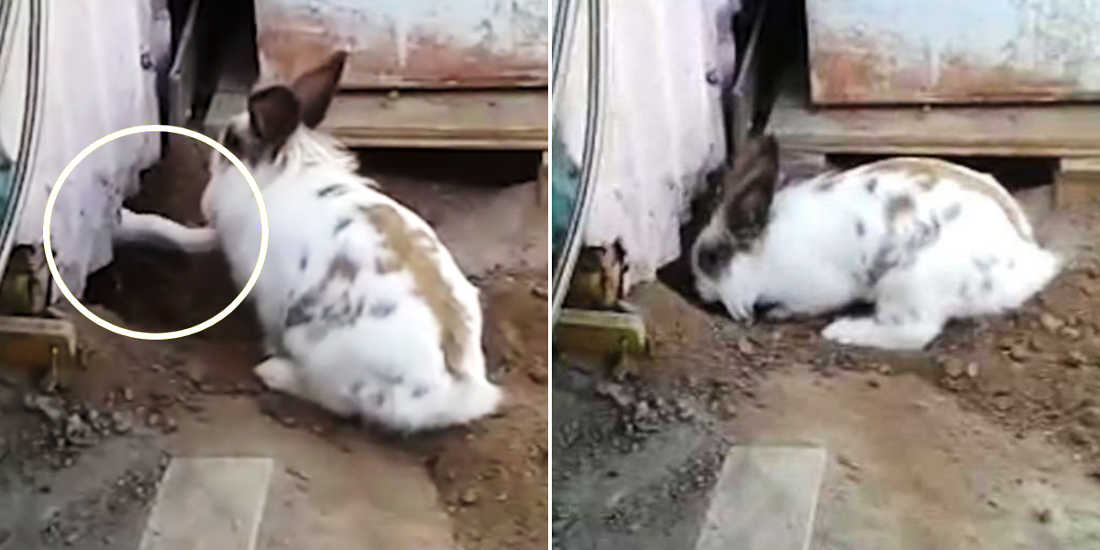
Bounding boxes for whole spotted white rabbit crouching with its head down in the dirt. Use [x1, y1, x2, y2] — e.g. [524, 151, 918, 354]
[691, 135, 1063, 350]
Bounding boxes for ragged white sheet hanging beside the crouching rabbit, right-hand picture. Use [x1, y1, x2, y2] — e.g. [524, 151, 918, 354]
[554, 0, 740, 288]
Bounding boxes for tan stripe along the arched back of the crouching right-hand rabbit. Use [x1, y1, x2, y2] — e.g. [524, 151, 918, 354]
[865, 157, 1034, 242]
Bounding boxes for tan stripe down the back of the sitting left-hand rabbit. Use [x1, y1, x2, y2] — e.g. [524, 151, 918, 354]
[363, 205, 471, 378]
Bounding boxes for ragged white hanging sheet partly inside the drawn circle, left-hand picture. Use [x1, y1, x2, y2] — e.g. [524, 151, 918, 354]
[15, 0, 171, 299]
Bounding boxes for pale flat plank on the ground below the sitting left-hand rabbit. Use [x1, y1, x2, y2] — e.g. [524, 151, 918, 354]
[139, 458, 274, 550]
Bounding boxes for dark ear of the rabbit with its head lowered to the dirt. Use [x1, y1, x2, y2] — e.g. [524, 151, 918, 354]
[726, 135, 779, 228]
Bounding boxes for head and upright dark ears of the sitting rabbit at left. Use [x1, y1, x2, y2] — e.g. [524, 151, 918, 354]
[201, 52, 348, 220]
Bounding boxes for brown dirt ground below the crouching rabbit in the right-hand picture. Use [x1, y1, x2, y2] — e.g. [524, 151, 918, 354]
[551, 180, 1100, 550]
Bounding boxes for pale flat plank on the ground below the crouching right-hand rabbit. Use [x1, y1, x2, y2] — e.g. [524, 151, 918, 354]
[695, 447, 826, 550]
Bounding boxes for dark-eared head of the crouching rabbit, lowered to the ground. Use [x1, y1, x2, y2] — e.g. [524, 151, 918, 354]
[691, 135, 779, 301]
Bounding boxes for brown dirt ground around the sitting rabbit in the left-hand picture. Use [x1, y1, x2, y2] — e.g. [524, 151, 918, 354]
[0, 135, 548, 550]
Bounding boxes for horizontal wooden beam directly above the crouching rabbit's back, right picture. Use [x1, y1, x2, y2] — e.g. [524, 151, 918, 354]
[769, 70, 1100, 157]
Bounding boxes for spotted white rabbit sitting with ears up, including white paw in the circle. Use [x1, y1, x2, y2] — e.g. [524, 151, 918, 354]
[120, 53, 502, 432]
